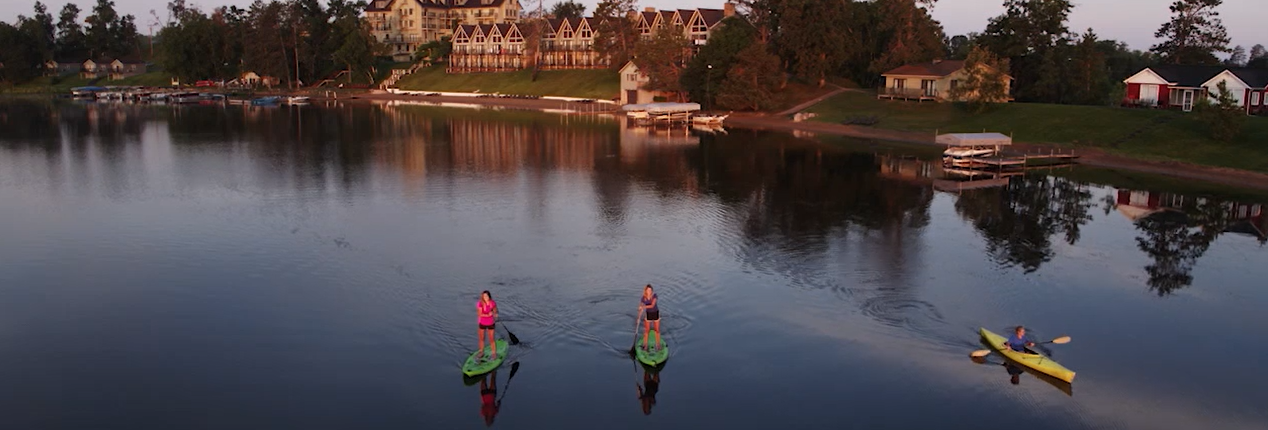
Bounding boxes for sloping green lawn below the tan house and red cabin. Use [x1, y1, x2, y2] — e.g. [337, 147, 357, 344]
[809, 93, 1268, 173]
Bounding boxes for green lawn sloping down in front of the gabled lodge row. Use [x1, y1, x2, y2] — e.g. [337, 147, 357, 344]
[397, 66, 621, 100]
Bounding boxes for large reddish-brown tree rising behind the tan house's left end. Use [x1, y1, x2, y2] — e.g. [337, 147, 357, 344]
[869, 0, 946, 76]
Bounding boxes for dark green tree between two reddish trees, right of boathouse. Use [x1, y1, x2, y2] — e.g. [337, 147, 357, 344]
[681, 16, 750, 107]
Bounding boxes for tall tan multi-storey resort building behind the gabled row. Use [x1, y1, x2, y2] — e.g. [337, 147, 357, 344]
[365, 0, 521, 61]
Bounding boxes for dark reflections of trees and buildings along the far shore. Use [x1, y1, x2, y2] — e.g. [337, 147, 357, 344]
[0, 99, 1268, 298]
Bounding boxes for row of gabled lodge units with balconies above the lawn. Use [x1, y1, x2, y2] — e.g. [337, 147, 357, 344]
[446, 5, 735, 74]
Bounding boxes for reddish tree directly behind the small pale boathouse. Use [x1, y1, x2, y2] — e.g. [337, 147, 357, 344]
[634, 25, 691, 100]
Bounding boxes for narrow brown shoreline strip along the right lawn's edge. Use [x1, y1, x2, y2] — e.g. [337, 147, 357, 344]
[727, 113, 1268, 190]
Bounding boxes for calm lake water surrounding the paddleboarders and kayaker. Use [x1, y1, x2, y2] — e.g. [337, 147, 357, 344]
[0, 100, 1268, 429]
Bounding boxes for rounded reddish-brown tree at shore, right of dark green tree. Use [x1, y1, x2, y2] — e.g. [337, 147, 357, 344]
[718, 41, 784, 110]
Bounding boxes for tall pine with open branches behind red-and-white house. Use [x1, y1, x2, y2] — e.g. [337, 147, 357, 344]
[1150, 0, 1231, 65]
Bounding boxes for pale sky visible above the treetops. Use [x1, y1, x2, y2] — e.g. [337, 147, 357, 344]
[0, 0, 1268, 49]
